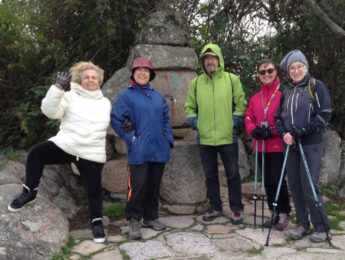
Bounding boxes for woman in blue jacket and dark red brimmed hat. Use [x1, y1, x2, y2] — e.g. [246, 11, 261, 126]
[111, 57, 174, 239]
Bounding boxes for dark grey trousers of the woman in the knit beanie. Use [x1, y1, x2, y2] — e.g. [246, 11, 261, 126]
[284, 142, 330, 232]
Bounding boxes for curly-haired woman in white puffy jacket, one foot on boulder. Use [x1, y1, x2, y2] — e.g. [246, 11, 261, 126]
[8, 62, 111, 243]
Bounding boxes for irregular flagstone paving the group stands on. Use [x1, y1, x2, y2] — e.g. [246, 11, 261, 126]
[70, 197, 345, 260]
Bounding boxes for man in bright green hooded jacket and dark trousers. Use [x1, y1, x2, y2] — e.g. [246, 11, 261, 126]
[184, 44, 247, 224]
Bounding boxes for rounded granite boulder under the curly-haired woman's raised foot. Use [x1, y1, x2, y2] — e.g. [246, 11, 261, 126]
[0, 184, 69, 260]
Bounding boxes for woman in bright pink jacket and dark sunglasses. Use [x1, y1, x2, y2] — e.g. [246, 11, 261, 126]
[245, 59, 291, 230]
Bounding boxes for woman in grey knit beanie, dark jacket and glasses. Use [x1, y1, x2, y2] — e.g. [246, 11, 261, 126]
[275, 50, 332, 242]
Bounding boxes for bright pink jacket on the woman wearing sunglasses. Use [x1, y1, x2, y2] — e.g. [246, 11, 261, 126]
[245, 76, 283, 152]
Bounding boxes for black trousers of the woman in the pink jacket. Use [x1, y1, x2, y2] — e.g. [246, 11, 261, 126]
[258, 152, 291, 215]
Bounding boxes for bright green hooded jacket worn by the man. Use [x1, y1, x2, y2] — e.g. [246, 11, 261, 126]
[184, 43, 247, 146]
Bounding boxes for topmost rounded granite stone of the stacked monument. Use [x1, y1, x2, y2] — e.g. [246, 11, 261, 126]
[135, 11, 189, 46]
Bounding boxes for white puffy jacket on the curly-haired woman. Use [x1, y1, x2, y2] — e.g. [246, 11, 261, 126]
[41, 82, 111, 163]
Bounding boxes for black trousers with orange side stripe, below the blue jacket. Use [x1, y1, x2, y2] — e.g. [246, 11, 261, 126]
[126, 162, 165, 220]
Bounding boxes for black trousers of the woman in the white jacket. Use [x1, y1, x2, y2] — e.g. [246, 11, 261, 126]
[25, 141, 104, 220]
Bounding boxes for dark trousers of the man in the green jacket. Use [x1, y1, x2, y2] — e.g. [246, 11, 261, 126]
[199, 143, 244, 211]
